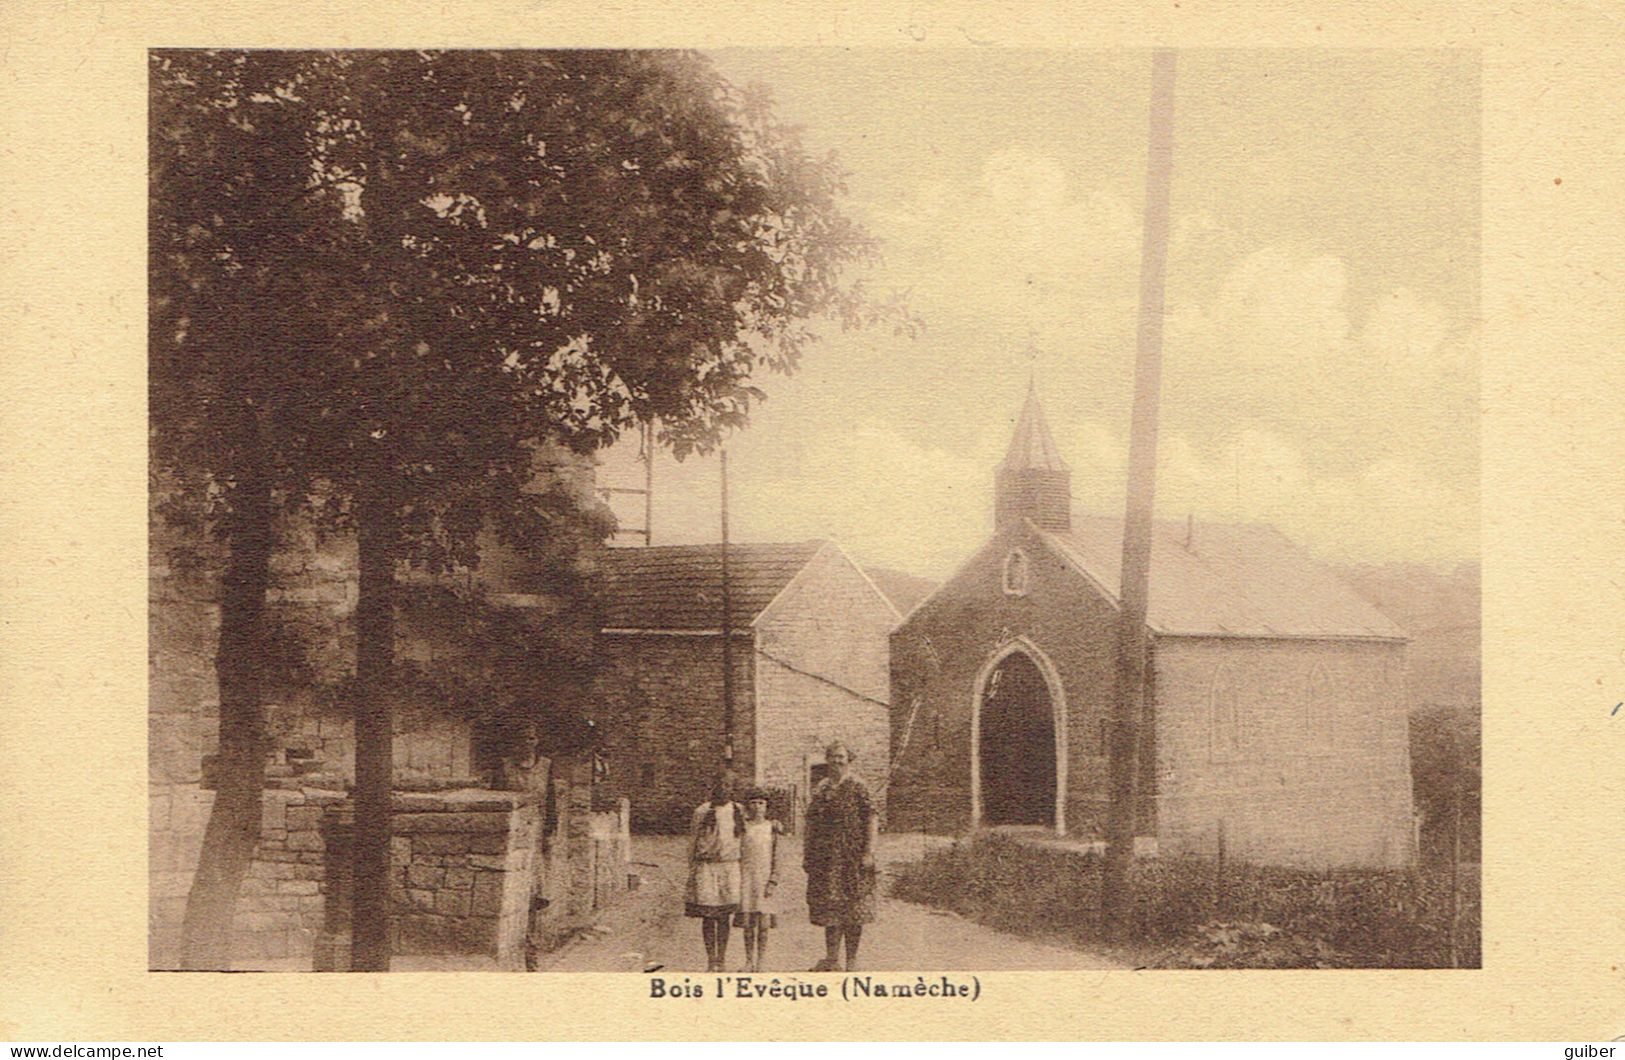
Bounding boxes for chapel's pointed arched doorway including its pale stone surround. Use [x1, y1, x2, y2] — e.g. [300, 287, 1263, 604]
[972, 641, 1066, 831]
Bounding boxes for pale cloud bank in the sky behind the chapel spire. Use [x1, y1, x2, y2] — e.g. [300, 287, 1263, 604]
[591, 217, 1477, 577]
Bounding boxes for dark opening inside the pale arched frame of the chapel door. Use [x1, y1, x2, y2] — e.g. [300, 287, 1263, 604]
[978, 652, 1055, 824]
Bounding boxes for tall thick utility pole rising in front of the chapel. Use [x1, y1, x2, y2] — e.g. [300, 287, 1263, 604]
[1100, 49, 1175, 940]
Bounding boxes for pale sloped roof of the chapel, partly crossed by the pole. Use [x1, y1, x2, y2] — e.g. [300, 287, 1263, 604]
[1040, 515, 1406, 641]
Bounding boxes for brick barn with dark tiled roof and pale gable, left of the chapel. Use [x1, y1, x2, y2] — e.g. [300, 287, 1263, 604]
[593, 541, 899, 831]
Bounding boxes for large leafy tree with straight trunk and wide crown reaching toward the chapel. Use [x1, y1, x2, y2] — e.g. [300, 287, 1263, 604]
[151, 52, 907, 969]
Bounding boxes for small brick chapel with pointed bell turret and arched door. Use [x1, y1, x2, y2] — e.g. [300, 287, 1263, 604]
[889, 392, 1414, 867]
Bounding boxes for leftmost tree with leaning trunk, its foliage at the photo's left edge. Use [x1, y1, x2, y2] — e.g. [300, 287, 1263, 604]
[148, 52, 352, 967]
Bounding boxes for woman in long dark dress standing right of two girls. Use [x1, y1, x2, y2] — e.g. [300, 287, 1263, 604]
[803, 743, 881, 972]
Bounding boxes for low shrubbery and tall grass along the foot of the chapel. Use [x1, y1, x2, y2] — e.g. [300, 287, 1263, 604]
[891, 836, 1479, 967]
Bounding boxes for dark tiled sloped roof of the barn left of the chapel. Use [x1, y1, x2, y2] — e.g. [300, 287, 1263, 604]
[600, 541, 826, 629]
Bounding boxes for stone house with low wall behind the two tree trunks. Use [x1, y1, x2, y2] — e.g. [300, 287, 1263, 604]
[148, 448, 629, 967]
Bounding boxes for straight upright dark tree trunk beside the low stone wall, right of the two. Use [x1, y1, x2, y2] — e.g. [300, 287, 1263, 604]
[349, 475, 397, 972]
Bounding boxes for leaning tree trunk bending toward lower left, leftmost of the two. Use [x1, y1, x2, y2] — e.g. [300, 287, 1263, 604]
[180, 413, 271, 969]
